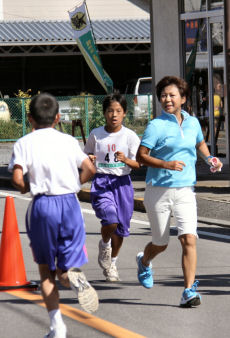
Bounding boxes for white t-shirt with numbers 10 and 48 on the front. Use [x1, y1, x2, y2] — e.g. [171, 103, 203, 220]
[84, 126, 140, 176]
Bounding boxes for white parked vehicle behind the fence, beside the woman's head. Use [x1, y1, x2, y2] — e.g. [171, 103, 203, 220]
[125, 77, 152, 119]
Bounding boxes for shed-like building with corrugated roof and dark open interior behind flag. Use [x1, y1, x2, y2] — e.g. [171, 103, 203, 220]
[0, 0, 151, 97]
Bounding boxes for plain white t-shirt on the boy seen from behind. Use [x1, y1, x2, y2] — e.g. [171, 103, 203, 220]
[8, 128, 87, 196]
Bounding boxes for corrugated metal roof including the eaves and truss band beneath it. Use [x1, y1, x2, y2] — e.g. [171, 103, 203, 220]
[0, 20, 150, 57]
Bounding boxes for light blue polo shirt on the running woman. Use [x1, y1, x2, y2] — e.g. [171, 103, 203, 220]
[141, 110, 204, 187]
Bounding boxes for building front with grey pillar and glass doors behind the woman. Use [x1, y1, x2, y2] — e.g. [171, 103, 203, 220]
[151, 0, 230, 167]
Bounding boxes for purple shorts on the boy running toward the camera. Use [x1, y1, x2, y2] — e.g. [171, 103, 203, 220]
[90, 174, 134, 237]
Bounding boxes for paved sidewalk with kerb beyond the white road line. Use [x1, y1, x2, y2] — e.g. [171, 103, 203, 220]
[0, 143, 230, 226]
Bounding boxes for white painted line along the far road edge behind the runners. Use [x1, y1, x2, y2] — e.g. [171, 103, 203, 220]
[0, 192, 230, 240]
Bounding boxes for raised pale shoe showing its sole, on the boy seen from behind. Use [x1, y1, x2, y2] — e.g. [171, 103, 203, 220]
[67, 268, 99, 313]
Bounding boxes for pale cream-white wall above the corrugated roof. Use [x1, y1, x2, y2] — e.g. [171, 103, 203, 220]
[0, 0, 149, 21]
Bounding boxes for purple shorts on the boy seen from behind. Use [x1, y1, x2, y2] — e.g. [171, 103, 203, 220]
[26, 194, 88, 271]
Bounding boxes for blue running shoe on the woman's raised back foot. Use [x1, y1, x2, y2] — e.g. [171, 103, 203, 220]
[136, 252, 153, 289]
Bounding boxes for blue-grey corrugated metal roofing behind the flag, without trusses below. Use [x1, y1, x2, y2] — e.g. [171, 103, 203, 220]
[0, 20, 150, 46]
